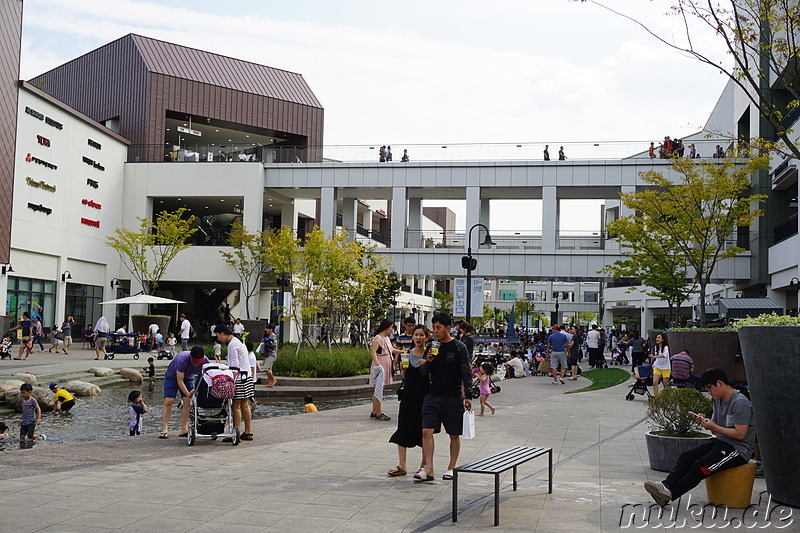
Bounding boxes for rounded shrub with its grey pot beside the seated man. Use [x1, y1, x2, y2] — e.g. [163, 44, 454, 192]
[645, 388, 714, 472]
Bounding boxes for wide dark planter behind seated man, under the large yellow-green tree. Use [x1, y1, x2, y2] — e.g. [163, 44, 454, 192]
[667, 331, 747, 381]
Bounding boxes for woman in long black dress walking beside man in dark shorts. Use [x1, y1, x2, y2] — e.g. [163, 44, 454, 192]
[389, 324, 431, 476]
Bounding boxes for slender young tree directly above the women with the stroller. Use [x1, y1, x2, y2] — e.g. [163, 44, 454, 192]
[219, 222, 270, 320]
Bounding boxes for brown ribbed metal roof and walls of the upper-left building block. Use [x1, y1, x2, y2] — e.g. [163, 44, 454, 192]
[31, 34, 324, 161]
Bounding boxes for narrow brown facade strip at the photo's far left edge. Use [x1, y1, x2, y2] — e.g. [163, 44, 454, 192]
[0, 0, 22, 263]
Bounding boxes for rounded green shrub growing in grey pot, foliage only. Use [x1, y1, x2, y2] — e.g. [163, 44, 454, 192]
[647, 388, 714, 437]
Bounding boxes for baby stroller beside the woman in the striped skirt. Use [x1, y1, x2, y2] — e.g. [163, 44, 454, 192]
[187, 364, 241, 446]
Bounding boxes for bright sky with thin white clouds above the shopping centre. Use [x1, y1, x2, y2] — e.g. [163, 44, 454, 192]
[21, 0, 727, 229]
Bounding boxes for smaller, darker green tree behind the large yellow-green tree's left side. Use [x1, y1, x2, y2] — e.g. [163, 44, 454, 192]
[601, 221, 697, 326]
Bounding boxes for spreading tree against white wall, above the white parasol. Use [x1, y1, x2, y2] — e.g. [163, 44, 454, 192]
[106, 207, 197, 294]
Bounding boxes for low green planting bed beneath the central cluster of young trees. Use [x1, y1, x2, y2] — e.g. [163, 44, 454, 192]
[272, 346, 372, 378]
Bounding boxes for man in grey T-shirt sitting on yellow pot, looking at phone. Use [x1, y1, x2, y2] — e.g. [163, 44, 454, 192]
[644, 368, 756, 507]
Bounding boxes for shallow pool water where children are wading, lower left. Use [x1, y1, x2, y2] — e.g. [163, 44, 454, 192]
[0, 384, 376, 451]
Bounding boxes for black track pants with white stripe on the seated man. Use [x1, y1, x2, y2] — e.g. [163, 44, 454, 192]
[664, 439, 749, 500]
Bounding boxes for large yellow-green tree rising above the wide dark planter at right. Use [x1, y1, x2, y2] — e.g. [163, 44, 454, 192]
[615, 156, 769, 327]
